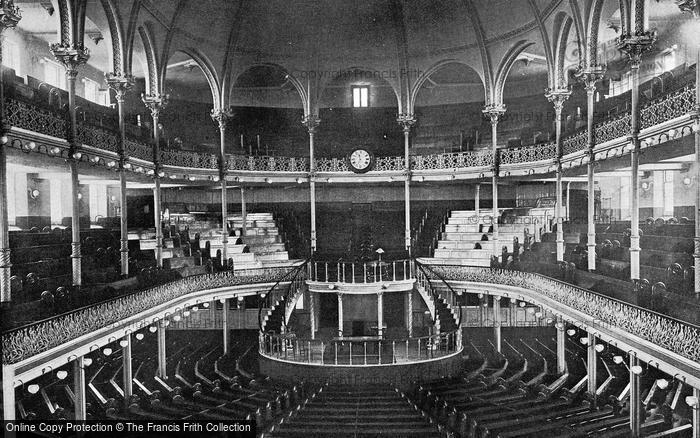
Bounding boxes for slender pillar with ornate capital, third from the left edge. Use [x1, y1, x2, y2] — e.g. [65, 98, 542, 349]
[105, 74, 134, 278]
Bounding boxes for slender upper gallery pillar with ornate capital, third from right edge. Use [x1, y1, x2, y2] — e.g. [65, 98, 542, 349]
[567, 65, 605, 271]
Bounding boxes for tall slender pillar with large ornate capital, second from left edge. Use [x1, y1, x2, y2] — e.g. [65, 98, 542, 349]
[51, 44, 89, 287]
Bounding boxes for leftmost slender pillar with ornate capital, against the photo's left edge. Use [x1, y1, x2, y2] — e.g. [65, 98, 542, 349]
[0, 1, 22, 304]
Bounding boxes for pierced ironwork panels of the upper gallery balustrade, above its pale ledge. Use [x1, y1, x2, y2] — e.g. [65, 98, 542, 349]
[4, 81, 696, 174]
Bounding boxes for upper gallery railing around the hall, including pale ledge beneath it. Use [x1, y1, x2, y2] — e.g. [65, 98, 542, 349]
[4, 85, 696, 178]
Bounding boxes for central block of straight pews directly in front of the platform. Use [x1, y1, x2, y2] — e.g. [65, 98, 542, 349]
[265, 385, 441, 438]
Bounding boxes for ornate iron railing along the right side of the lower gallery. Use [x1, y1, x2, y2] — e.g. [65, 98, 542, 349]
[418, 265, 700, 362]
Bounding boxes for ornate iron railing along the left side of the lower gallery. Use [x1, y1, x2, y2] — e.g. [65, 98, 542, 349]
[2, 267, 294, 364]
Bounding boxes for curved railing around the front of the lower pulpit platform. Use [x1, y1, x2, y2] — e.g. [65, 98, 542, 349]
[259, 331, 462, 366]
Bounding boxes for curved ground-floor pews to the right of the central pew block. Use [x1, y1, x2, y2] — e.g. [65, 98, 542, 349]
[412, 328, 687, 438]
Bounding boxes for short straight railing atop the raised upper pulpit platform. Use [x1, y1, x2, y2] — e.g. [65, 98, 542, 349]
[307, 260, 415, 283]
